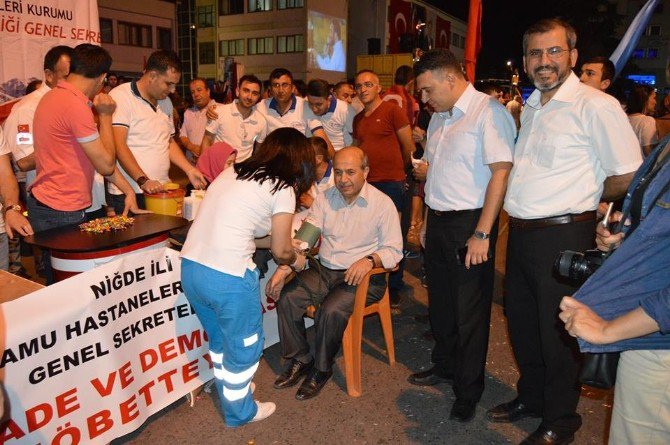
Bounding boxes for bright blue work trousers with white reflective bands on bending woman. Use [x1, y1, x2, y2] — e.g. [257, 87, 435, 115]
[181, 258, 265, 426]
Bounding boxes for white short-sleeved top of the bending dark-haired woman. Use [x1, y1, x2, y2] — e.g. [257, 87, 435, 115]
[181, 168, 296, 277]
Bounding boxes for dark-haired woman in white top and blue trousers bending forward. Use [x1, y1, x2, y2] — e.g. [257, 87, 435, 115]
[181, 128, 314, 426]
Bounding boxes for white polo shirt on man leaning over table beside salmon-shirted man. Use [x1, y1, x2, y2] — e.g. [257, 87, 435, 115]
[109, 82, 175, 195]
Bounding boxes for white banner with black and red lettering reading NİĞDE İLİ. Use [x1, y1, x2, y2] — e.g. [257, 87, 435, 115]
[0, 248, 212, 444]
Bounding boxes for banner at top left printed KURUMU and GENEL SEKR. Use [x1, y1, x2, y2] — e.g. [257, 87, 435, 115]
[0, 0, 100, 116]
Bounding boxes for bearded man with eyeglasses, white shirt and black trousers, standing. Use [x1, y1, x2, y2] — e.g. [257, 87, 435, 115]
[487, 19, 642, 444]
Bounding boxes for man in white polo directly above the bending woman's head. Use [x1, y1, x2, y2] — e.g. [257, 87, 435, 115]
[258, 68, 332, 148]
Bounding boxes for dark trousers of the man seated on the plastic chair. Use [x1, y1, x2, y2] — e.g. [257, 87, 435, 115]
[277, 261, 386, 371]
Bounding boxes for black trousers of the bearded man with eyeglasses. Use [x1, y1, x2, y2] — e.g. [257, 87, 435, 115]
[505, 221, 595, 431]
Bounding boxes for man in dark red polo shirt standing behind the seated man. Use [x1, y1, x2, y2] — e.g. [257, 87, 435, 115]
[353, 70, 414, 308]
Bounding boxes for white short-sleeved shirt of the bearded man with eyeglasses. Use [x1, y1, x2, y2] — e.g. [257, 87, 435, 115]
[505, 73, 642, 219]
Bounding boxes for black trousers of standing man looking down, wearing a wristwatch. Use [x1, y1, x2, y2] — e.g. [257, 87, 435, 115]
[425, 209, 498, 403]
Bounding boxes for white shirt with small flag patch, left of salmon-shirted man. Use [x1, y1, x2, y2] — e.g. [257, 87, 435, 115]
[3, 82, 51, 188]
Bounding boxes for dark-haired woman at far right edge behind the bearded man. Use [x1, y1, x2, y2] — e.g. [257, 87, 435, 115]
[626, 84, 658, 157]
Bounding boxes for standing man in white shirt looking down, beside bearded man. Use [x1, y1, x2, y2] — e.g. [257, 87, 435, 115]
[409, 49, 516, 422]
